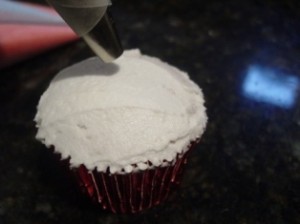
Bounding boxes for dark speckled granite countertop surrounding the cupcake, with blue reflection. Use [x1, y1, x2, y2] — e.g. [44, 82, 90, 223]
[0, 0, 300, 224]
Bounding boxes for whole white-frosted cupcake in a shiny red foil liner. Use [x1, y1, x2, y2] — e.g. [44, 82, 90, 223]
[35, 50, 207, 213]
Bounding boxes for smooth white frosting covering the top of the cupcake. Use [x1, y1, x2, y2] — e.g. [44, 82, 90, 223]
[35, 50, 207, 173]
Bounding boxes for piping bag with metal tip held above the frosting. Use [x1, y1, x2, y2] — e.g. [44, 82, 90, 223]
[47, 0, 123, 63]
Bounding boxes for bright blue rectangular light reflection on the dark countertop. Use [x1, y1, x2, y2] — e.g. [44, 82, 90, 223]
[243, 65, 299, 108]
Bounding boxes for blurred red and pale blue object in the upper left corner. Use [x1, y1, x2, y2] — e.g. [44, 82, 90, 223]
[0, 0, 78, 68]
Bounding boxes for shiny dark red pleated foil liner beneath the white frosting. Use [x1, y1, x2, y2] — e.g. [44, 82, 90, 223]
[72, 149, 188, 213]
